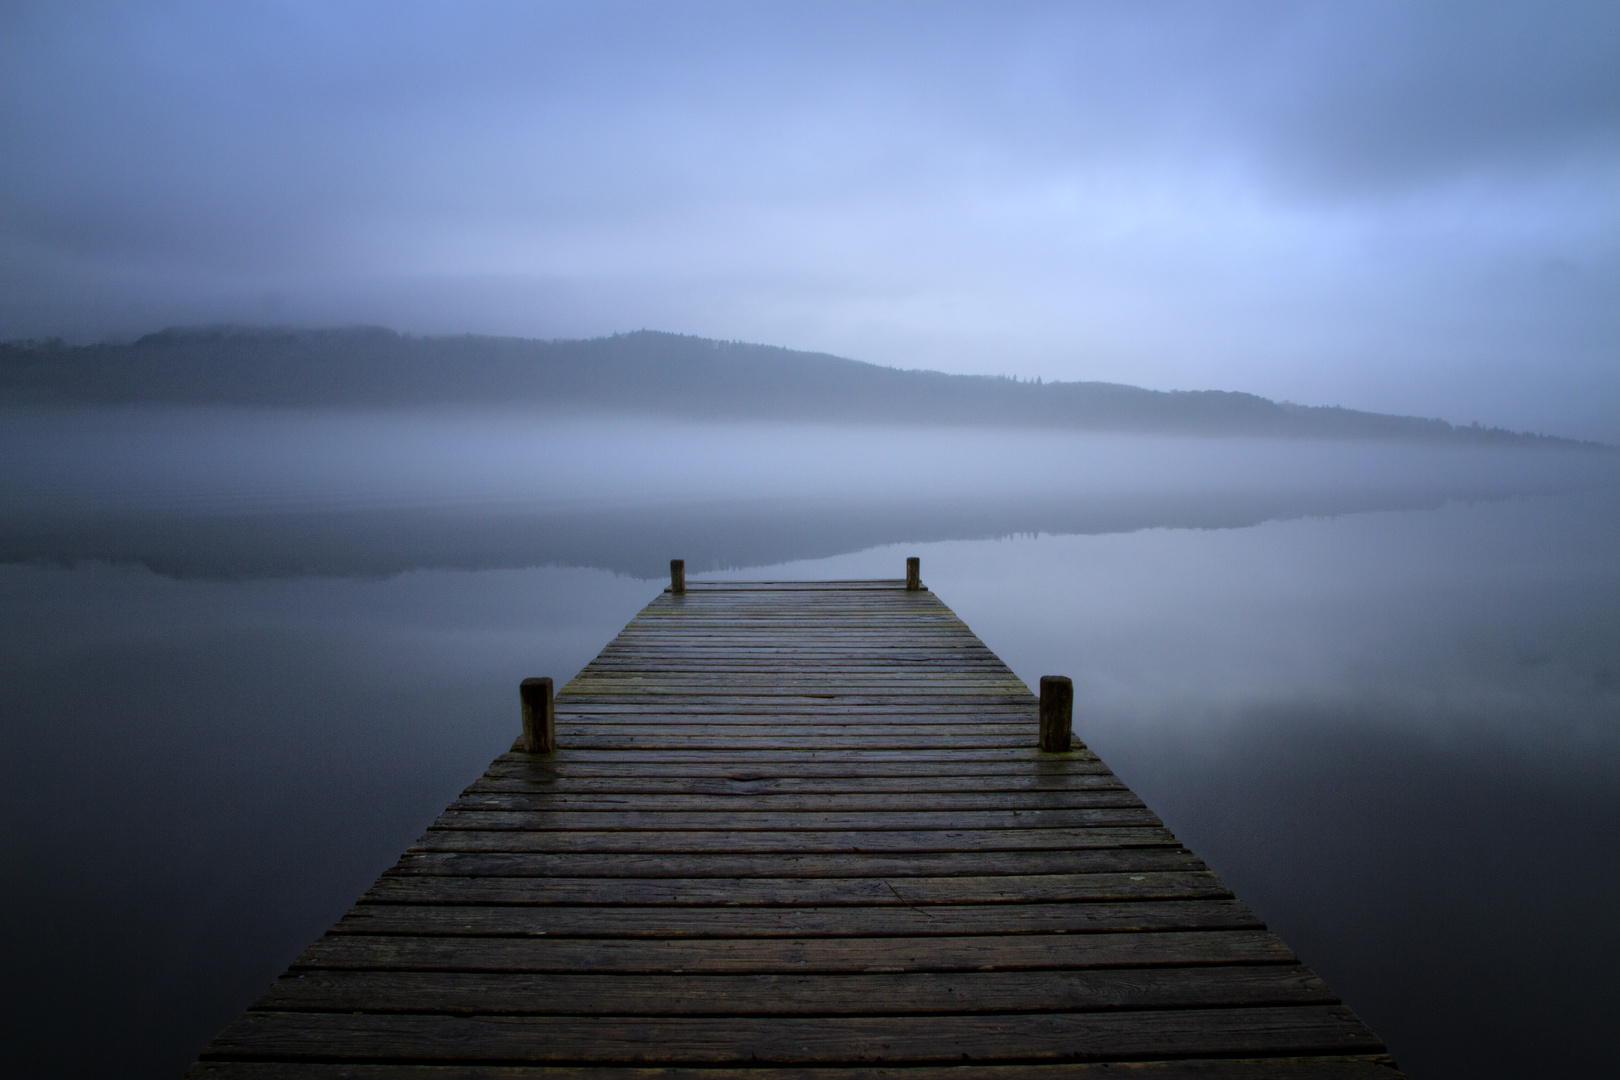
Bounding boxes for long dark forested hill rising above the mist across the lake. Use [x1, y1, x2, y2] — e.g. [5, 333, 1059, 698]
[0, 327, 1597, 445]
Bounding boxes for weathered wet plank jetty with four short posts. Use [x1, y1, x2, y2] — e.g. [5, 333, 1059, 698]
[186, 562, 1400, 1080]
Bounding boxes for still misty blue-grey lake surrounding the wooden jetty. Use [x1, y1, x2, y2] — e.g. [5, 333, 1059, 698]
[0, 410, 1620, 1080]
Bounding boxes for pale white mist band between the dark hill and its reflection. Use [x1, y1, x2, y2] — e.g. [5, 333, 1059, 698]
[0, 406, 1620, 515]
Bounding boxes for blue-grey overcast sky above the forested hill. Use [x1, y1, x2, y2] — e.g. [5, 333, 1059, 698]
[0, 0, 1620, 439]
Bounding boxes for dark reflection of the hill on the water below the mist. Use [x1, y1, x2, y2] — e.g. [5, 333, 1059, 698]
[0, 487, 1555, 578]
